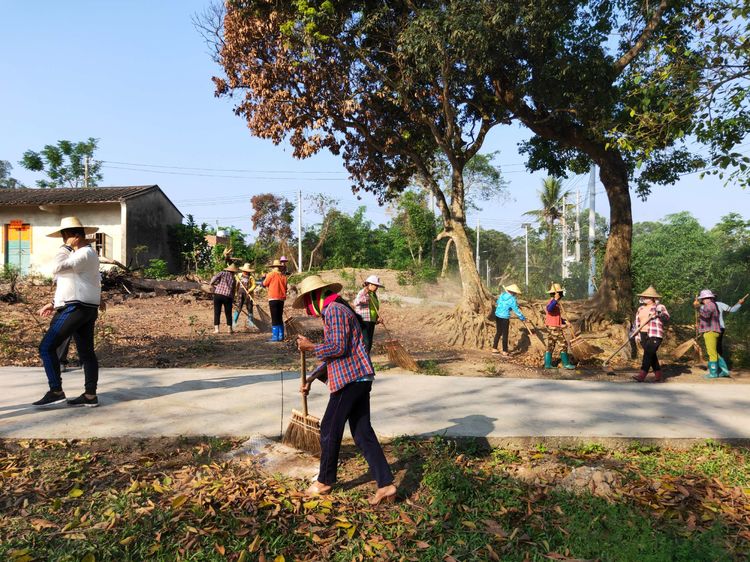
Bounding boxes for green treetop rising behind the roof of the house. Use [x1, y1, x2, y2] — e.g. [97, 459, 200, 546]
[20, 137, 102, 187]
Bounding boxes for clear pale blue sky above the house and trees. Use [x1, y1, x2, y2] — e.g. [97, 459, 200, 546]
[0, 0, 750, 235]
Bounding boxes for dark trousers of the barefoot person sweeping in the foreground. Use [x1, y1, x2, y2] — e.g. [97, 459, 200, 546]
[318, 382, 393, 488]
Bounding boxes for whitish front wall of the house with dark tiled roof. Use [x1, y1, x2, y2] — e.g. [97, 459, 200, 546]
[0, 203, 125, 276]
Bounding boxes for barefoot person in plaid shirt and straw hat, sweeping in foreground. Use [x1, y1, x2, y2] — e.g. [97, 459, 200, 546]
[293, 275, 397, 505]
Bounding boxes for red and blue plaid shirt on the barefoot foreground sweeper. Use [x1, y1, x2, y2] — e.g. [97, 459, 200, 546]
[315, 302, 375, 392]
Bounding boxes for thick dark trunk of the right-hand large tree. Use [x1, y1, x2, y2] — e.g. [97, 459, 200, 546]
[590, 152, 633, 319]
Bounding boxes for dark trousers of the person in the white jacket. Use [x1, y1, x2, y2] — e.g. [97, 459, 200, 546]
[39, 304, 99, 394]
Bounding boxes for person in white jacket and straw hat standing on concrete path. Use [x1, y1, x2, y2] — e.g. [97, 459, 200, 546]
[34, 217, 104, 407]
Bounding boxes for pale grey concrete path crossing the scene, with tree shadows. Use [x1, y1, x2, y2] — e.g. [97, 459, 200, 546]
[0, 367, 750, 440]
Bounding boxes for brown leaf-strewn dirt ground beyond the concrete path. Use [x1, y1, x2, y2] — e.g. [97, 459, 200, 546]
[0, 270, 750, 384]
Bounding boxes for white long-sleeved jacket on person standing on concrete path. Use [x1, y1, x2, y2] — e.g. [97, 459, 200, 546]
[52, 246, 102, 308]
